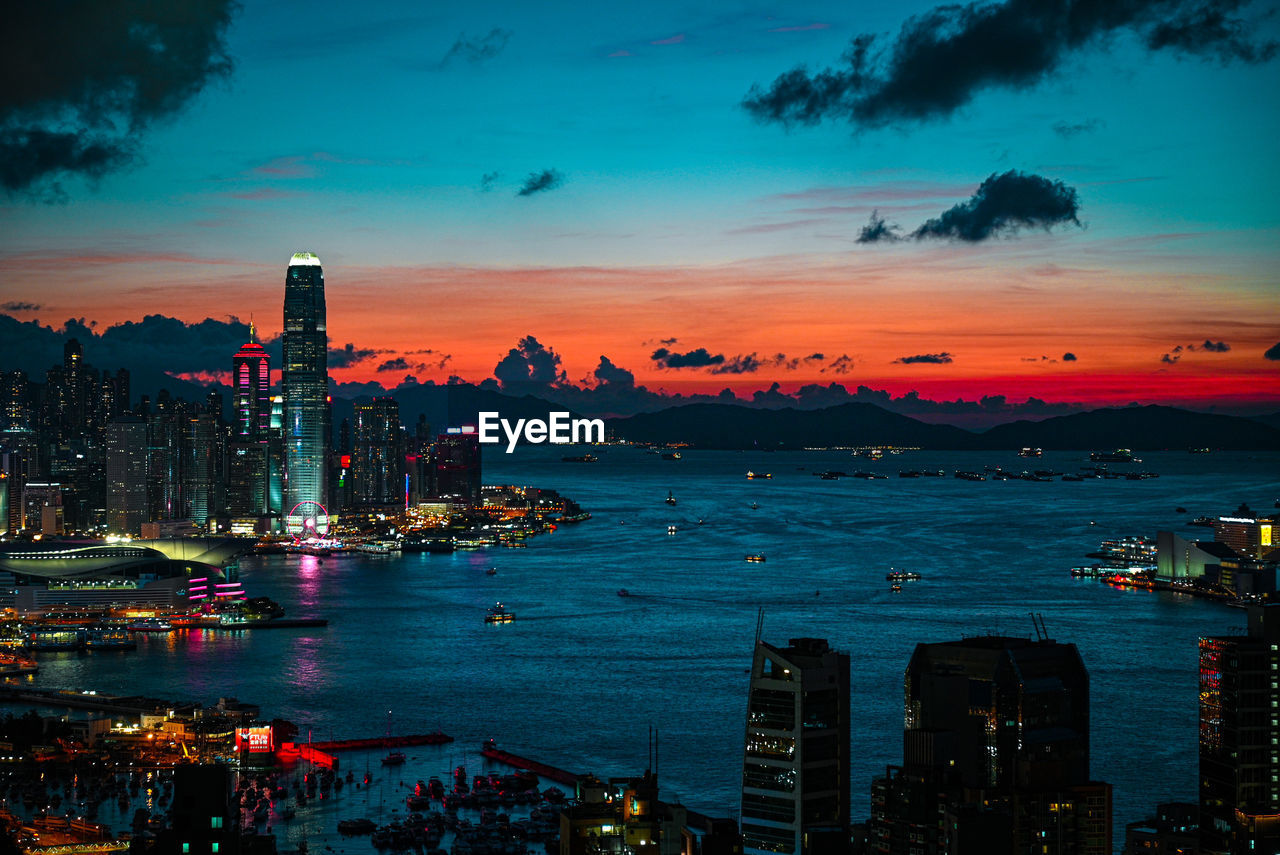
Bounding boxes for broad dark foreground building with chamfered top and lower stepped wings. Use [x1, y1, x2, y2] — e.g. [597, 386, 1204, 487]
[868, 636, 1111, 855]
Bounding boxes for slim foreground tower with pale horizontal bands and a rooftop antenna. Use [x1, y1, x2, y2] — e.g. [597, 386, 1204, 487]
[742, 639, 850, 855]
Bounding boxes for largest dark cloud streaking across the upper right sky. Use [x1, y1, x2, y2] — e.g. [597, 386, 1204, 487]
[742, 0, 1276, 128]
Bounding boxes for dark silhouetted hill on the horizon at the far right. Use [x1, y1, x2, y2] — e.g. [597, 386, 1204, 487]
[978, 406, 1280, 451]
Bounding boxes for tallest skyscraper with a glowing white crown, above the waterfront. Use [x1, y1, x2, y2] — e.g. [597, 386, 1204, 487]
[280, 252, 329, 536]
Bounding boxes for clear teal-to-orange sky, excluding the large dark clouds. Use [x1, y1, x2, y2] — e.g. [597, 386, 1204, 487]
[0, 0, 1280, 399]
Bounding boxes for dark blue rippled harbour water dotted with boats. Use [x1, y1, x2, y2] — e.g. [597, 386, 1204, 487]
[15, 447, 1280, 851]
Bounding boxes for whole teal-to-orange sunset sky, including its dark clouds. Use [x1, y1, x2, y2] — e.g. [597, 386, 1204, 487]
[0, 0, 1280, 410]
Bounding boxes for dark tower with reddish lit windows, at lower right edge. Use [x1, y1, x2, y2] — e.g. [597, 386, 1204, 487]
[1199, 605, 1280, 855]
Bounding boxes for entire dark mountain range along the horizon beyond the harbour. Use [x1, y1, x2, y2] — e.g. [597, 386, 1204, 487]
[333, 384, 1280, 451]
